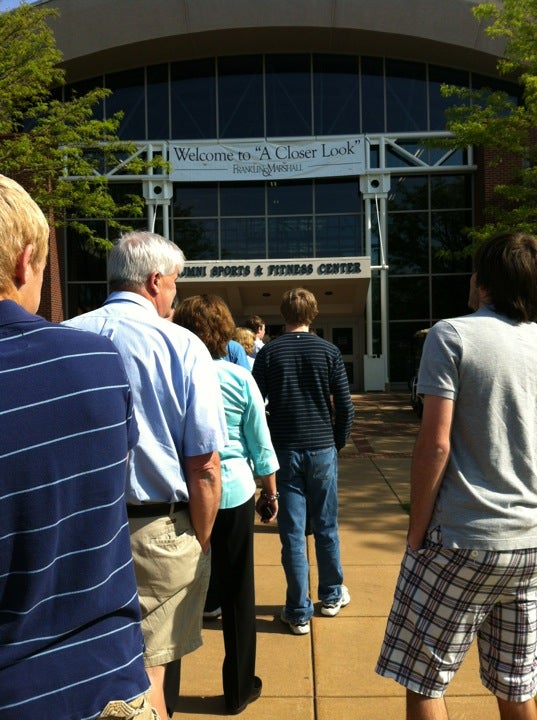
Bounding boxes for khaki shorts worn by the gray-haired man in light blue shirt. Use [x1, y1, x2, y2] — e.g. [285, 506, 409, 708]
[129, 509, 211, 667]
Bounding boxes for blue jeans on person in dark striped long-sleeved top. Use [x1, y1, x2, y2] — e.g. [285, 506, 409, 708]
[276, 447, 343, 622]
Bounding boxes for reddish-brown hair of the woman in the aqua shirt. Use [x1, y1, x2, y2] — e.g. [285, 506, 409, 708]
[173, 295, 235, 360]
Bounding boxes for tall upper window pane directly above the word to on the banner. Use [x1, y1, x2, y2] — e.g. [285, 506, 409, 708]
[218, 55, 265, 138]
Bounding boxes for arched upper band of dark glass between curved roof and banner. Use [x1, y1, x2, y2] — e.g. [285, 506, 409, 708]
[65, 54, 515, 140]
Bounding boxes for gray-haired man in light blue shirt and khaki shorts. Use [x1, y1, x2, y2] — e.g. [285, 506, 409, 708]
[67, 232, 227, 717]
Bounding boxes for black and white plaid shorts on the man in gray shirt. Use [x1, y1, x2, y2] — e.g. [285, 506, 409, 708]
[375, 544, 537, 702]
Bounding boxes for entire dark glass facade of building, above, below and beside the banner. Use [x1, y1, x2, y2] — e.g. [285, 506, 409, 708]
[64, 54, 520, 382]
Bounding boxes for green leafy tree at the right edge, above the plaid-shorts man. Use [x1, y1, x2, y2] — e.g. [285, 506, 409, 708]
[443, 0, 537, 242]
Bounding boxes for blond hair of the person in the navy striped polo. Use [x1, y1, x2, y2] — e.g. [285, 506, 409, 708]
[0, 175, 50, 292]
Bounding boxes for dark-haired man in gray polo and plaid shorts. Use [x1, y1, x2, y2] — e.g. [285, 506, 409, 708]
[376, 233, 537, 720]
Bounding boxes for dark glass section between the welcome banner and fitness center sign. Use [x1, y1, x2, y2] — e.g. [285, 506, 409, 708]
[172, 178, 363, 260]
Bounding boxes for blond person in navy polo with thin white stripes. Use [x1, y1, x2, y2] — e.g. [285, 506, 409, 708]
[0, 175, 156, 720]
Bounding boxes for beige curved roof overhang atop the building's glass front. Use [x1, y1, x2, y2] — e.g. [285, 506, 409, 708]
[42, 0, 503, 81]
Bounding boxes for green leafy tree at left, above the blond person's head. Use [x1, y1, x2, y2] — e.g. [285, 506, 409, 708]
[0, 4, 149, 246]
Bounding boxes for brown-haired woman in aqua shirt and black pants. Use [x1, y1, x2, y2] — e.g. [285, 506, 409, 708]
[174, 295, 278, 715]
